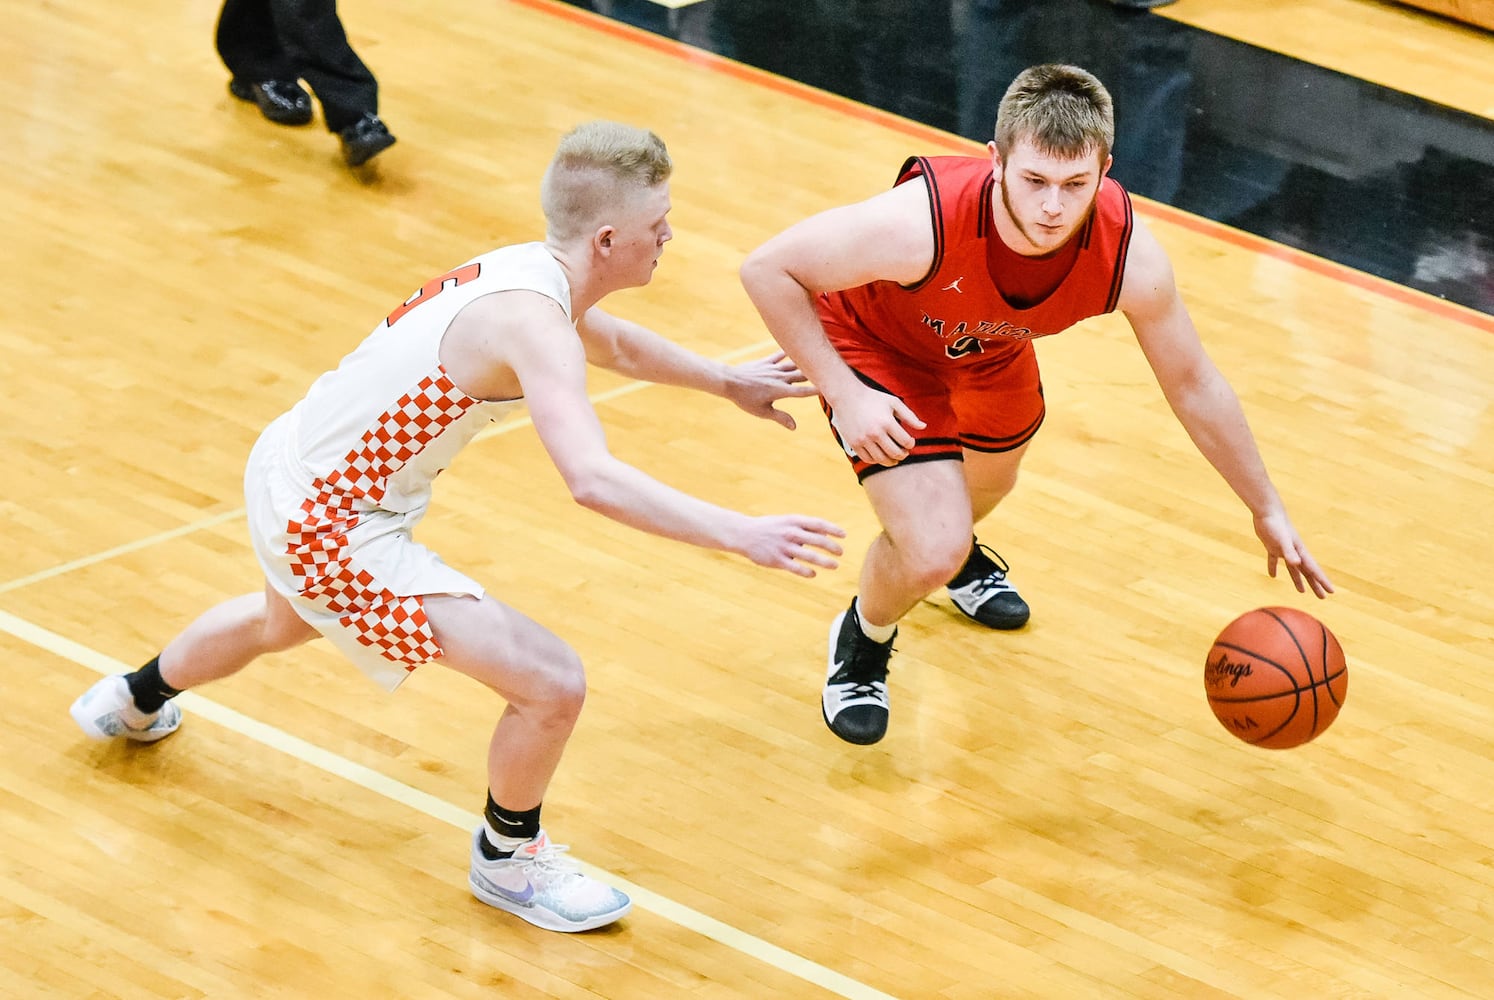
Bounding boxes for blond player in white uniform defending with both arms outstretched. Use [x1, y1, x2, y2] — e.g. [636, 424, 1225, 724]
[72, 123, 844, 931]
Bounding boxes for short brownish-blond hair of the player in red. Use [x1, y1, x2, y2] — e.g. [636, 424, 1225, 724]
[995, 63, 1116, 163]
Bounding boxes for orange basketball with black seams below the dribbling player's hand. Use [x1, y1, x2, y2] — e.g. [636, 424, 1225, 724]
[1204, 608, 1349, 750]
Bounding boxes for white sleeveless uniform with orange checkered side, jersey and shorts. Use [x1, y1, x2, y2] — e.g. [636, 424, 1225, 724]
[245, 244, 571, 689]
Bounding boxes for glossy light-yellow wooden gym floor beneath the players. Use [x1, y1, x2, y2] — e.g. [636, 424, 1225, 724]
[0, 0, 1494, 1000]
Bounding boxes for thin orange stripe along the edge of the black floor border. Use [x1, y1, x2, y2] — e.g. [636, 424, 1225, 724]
[509, 0, 1494, 333]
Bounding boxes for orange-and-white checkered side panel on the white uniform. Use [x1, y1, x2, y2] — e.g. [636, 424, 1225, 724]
[285, 368, 478, 670]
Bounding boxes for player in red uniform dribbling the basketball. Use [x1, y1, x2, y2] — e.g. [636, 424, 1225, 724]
[741, 66, 1333, 744]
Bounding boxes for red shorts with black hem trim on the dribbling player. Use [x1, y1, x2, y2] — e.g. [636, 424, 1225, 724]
[820, 312, 1046, 480]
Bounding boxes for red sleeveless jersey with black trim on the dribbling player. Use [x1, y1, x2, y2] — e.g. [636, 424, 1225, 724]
[820, 157, 1132, 363]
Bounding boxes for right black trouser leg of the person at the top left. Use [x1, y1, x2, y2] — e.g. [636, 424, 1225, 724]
[269, 0, 378, 132]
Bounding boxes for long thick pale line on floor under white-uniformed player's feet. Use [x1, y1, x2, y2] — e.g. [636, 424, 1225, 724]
[0, 611, 895, 1000]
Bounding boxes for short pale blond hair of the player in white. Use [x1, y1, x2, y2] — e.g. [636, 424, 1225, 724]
[539, 121, 674, 242]
